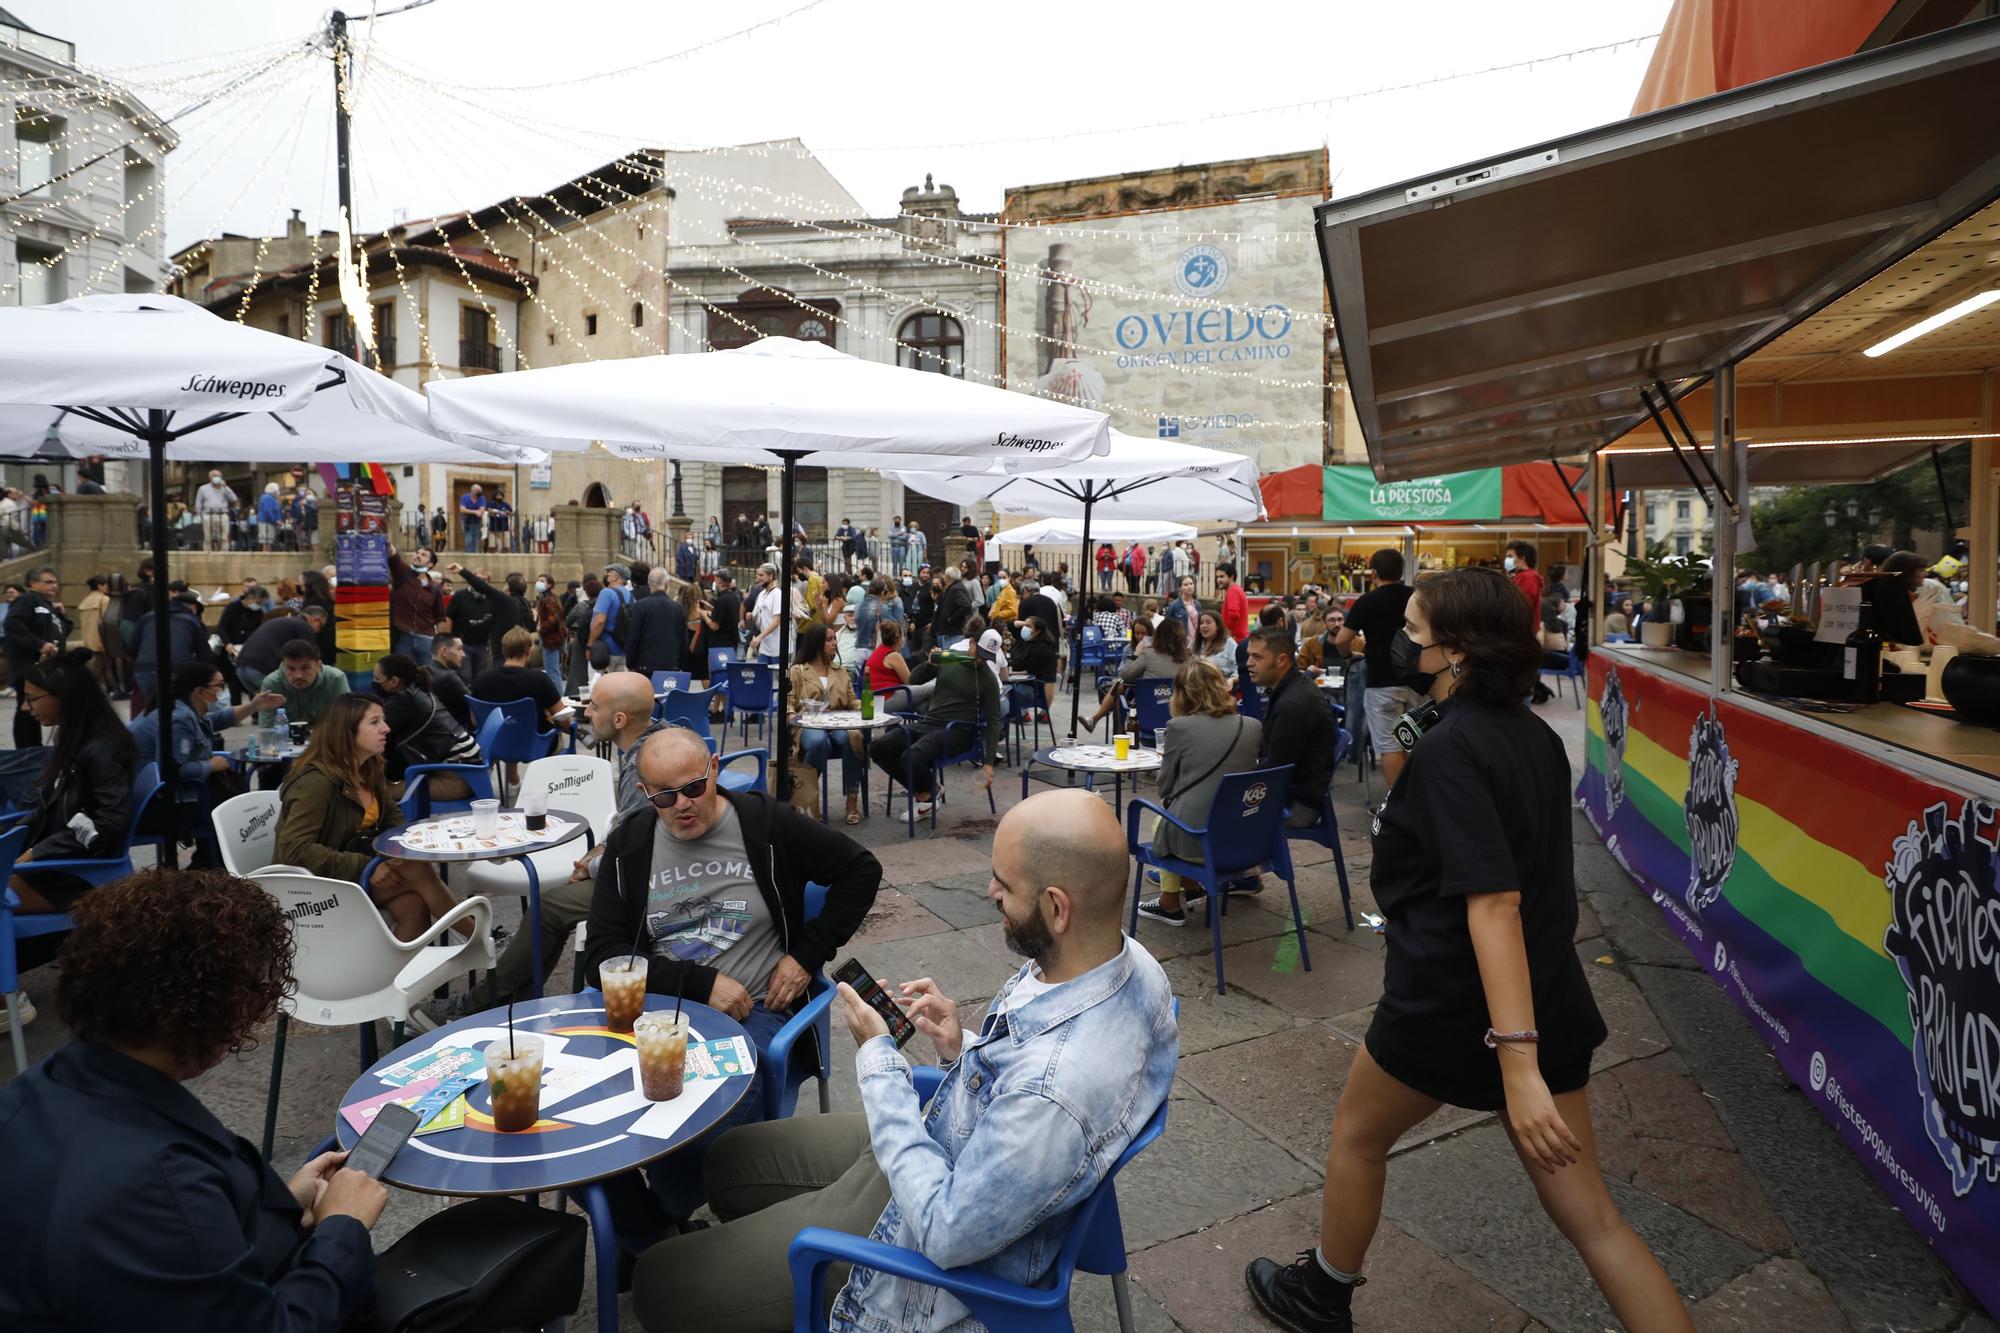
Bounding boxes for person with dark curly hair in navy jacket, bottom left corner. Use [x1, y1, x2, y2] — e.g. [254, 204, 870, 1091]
[0, 871, 388, 1333]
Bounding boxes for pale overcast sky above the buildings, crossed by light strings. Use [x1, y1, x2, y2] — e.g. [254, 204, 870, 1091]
[47, 0, 1670, 248]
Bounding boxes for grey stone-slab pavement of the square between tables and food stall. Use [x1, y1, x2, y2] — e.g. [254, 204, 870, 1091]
[0, 699, 2000, 1333]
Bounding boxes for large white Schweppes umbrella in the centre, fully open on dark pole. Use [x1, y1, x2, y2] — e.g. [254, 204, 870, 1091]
[430, 338, 1110, 788]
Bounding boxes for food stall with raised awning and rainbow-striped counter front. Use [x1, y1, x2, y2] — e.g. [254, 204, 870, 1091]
[1318, 20, 2000, 1309]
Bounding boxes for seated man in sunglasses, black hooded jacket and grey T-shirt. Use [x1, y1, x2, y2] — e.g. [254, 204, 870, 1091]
[586, 727, 882, 1221]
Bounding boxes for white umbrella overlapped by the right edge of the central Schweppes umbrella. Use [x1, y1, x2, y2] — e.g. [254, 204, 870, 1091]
[894, 430, 1264, 739]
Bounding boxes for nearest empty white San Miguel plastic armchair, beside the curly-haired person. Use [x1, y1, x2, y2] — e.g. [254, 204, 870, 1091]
[252, 871, 494, 1161]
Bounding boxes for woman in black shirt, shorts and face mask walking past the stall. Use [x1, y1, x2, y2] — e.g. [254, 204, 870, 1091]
[1246, 568, 1692, 1333]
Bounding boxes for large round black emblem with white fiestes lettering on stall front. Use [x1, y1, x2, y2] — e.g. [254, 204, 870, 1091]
[1882, 801, 2000, 1197]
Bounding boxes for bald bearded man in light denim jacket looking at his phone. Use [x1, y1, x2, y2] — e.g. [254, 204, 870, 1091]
[632, 791, 1180, 1333]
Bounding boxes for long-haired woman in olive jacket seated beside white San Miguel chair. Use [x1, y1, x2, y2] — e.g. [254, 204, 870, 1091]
[276, 695, 470, 939]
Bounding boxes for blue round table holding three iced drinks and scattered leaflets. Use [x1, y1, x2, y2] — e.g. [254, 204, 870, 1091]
[334, 991, 756, 1333]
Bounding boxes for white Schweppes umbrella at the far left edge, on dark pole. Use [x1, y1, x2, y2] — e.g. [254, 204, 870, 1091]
[0, 294, 544, 775]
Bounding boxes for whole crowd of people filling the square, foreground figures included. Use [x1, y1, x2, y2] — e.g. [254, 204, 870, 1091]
[0, 500, 1688, 1329]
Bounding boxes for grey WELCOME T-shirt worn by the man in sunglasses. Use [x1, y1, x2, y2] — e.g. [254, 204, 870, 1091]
[646, 805, 784, 995]
